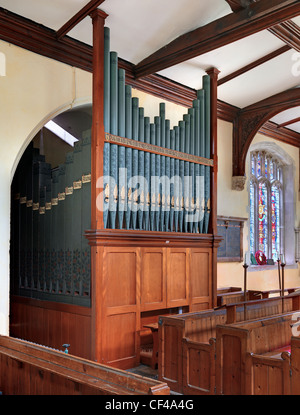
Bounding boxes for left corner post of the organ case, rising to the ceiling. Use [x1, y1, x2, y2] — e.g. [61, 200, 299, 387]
[90, 9, 107, 360]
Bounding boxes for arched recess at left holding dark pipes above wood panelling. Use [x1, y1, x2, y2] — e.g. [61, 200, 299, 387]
[10, 105, 92, 358]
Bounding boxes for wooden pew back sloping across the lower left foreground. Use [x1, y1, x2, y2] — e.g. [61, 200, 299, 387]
[0, 336, 170, 395]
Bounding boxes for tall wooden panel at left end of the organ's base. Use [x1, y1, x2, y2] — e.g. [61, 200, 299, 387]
[102, 247, 140, 369]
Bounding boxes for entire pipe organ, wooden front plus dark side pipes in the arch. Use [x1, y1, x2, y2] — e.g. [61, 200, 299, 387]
[11, 9, 220, 369]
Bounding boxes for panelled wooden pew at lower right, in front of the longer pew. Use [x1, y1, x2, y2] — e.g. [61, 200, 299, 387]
[216, 312, 295, 395]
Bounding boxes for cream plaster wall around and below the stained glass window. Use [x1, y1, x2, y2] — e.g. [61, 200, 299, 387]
[218, 120, 300, 290]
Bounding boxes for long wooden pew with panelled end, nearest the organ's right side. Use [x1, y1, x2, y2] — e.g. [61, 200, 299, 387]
[158, 295, 300, 394]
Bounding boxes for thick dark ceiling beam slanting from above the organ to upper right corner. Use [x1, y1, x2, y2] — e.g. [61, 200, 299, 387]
[135, 0, 300, 77]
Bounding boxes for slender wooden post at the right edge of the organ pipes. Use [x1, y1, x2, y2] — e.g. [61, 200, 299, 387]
[207, 68, 220, 307]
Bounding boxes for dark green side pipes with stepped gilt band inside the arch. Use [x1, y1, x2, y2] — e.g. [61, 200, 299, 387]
[11, 135, 91, 306]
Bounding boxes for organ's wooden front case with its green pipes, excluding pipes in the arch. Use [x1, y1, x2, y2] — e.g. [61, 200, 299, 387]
[86, 10, 220, 369]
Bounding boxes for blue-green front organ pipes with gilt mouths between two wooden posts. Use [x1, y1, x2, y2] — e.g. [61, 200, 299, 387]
[103, 27, 213, 234]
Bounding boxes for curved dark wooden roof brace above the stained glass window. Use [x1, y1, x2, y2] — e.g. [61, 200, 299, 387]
[233, 88, 300, 190]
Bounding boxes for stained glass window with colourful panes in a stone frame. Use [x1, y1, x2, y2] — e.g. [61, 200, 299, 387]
[250, 152, 282, 261]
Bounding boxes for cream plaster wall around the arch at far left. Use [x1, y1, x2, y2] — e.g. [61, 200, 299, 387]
[0, 41, 92, 335]
